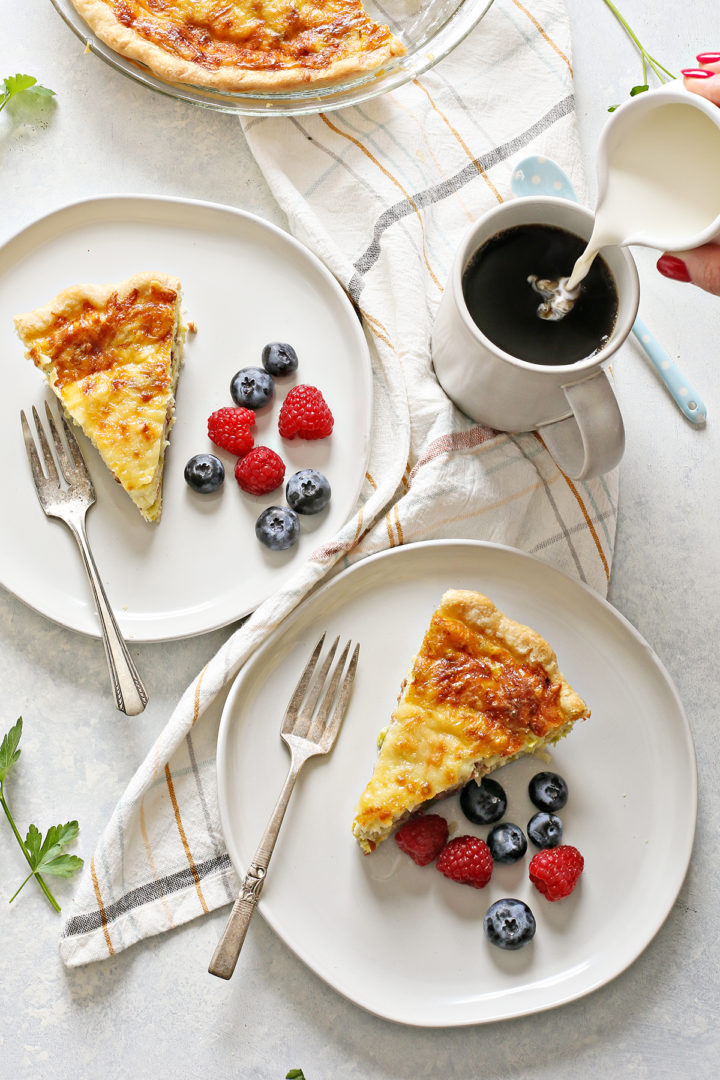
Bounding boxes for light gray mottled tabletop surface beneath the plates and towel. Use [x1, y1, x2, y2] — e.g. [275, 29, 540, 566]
[0, 0, 720, 1080]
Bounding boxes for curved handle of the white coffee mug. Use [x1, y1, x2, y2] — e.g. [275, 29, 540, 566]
[538, 368, 625, 480]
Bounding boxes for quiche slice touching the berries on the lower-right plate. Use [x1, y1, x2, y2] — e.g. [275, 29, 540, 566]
[353, 590, 589, 852]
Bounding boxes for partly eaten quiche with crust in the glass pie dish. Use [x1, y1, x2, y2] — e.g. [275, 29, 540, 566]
[72, 0, 405, 91]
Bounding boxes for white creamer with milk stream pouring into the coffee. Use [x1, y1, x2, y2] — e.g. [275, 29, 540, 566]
[566, 85, 720, 291]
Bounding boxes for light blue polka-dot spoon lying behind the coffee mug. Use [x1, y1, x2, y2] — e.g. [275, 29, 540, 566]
[511, 154, 707, 424]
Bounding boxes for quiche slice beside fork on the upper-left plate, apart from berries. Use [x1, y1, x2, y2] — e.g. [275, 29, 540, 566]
[15, 273, 186, 522]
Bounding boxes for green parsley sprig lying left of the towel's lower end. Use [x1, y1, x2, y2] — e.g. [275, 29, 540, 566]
[0, 717, 83, 912]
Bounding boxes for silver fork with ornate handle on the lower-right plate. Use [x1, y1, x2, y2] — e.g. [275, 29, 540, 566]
[207, 634, 359, 978]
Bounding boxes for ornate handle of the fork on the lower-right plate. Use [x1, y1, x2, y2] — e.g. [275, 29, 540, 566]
[207, 757, 305, 978]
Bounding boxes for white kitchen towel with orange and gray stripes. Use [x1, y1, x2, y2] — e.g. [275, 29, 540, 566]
[60, 0, 616, 964]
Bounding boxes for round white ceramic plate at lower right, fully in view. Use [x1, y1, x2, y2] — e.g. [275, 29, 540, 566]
[218, 541, 696, 1026]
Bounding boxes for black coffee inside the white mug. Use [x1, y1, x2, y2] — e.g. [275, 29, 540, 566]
[462, 225, 617, 365]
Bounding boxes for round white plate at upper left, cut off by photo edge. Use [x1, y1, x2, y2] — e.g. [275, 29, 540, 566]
[0, 195, 371, 642]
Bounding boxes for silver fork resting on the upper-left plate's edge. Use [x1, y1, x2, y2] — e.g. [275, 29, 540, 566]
[21, 402, 148, 716]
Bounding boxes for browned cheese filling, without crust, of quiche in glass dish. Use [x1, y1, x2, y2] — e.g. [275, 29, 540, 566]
[107, 0, 393, 71]
